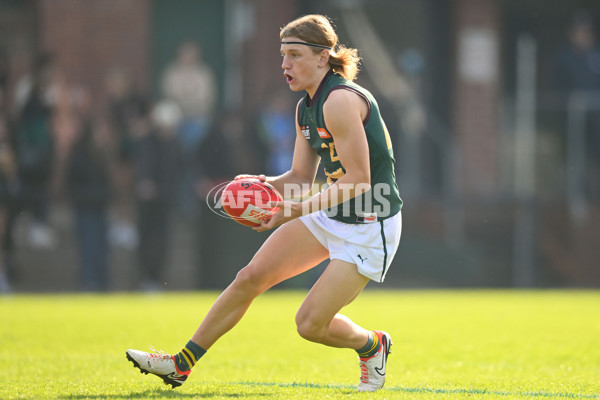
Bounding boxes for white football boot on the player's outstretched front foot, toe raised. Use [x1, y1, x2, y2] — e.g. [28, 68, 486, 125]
[126, 347, 192, 388]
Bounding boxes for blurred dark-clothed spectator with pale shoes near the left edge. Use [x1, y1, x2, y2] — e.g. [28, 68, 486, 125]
[14, 54, 57, 248]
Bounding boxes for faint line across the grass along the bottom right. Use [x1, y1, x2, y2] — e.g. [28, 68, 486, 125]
[228, 381, 600, 399]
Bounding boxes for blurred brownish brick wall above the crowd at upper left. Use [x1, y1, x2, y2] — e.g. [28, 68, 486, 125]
[38, 0, 150, 108]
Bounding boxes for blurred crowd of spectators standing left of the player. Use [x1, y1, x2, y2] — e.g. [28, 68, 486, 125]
[0, 42, 294, 292]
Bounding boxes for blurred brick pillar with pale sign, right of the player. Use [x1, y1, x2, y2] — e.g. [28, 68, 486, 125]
[453, 0, 501, 196]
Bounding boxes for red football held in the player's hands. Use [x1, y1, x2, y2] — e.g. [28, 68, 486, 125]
[221, 179, 283, 226]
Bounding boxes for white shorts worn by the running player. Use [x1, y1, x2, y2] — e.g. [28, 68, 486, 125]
[300, 211, 402, 282]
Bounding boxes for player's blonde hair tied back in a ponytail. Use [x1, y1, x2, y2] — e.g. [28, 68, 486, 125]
[279, 14, 361, 81]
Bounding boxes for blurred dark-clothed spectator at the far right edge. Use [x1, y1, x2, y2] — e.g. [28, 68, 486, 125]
[556, 10, 600, 195]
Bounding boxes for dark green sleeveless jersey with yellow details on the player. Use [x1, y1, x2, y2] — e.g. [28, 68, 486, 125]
[297, 71, 402, 224]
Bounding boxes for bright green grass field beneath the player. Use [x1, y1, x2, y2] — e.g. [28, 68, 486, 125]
[0, 291, 600, 400]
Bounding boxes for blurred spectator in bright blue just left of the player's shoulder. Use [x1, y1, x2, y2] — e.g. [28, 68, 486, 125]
[258, 90, 296, 175]
